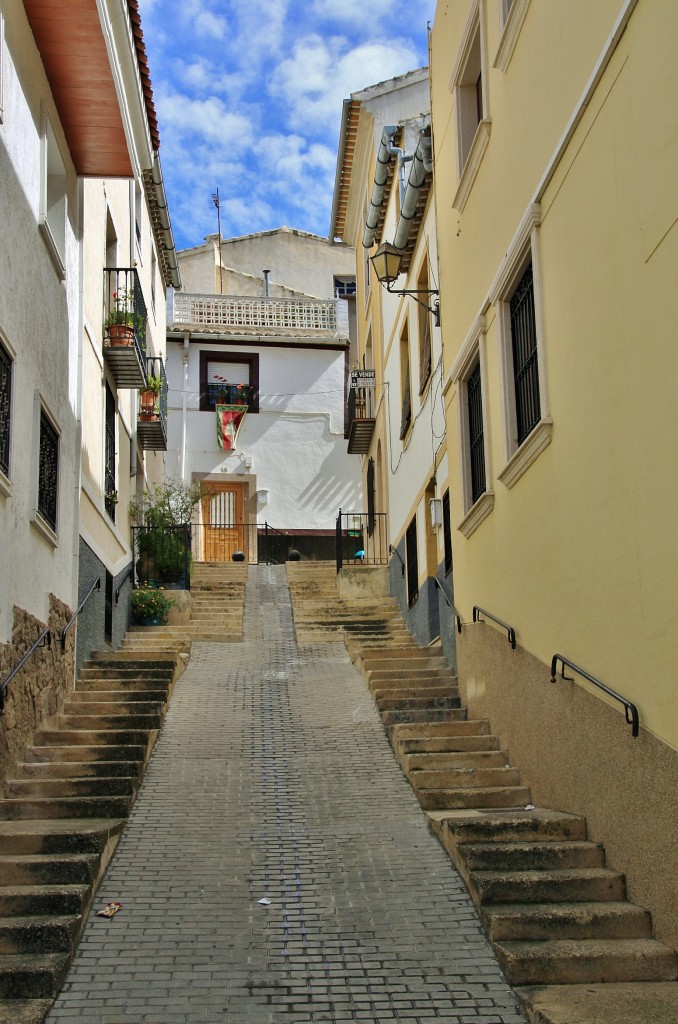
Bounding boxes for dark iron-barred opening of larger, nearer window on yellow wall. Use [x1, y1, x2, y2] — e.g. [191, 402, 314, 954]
[511, 263, 542, 444]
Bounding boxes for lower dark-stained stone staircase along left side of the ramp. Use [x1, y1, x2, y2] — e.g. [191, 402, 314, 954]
[0, 652, 181, 1024]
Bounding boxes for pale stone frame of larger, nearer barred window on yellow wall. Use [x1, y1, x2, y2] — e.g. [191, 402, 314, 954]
[490, 203, 553, 489]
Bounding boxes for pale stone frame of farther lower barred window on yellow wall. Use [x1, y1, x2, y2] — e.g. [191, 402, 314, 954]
[449, 314, 495, 538]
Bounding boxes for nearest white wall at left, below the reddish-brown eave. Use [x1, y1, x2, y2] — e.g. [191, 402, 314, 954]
[0, 0, 80, 641]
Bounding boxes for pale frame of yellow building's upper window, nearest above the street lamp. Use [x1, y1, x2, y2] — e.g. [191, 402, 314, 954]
[450, 0, 492, 213]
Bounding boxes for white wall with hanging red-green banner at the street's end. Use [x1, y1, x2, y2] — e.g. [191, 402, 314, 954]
[166, 342, 362, 530]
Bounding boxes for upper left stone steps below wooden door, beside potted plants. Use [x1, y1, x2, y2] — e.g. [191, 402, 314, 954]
[123, 562, 248, 653]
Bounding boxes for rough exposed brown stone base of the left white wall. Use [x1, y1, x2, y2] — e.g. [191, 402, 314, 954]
[0, 594, 75, 779]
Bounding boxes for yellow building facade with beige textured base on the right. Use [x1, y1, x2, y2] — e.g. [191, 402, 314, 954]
[431, 0, 678, 945]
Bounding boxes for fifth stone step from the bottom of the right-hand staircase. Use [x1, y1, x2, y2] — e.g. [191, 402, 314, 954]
[462, 842, 605, 871]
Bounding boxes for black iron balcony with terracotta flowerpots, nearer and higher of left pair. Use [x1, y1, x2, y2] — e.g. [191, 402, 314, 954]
[103, 267, 147, 388]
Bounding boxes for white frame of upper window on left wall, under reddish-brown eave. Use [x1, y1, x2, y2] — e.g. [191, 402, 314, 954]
[39, 108, 69, 280]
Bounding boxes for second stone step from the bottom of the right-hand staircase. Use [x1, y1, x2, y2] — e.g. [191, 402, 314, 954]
[495, 939, 678, 985]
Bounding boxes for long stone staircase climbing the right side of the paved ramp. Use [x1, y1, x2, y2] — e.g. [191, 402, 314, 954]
[289, 563, 678, 1024]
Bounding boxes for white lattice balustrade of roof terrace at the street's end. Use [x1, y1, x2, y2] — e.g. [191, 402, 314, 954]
[167, 292, 348, 338]
